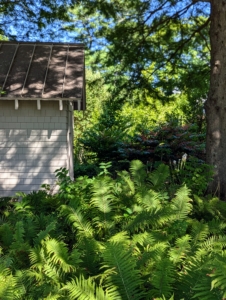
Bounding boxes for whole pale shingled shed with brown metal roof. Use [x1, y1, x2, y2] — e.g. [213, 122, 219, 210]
[0, 42, 85, 197]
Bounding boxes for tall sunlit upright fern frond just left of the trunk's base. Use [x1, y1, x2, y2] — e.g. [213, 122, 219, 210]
[171, 185, 192, 220]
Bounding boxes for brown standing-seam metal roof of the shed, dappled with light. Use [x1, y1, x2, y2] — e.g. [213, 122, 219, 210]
[0, 42, 85, 109]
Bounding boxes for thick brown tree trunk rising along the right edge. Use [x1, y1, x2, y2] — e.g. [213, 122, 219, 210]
[205, 0, 226, 200]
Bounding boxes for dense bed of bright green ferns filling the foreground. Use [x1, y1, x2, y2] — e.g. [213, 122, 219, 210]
[0, 160, 226, 300]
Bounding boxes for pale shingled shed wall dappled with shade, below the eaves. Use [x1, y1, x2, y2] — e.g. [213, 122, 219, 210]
[0, 99, 73, 197]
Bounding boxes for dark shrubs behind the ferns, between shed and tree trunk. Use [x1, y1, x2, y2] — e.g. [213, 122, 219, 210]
[74, 104, 206, 177]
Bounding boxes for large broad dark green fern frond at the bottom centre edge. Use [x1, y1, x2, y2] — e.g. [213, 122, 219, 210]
[102, 243, 143, 300]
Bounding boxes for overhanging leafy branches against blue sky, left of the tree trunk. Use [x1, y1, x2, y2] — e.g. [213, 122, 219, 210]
[67, 0, 210, 108]
